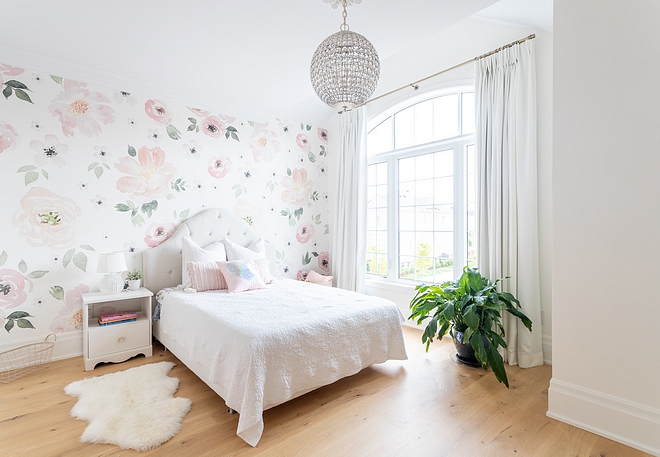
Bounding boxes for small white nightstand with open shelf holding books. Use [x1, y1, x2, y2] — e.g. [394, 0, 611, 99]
[82, 287, 153, 371]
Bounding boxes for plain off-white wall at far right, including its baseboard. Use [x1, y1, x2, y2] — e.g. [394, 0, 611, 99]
[548, 0, 660, 455]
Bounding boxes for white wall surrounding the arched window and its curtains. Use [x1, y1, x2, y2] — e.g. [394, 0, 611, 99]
[360, 19, 552, 363]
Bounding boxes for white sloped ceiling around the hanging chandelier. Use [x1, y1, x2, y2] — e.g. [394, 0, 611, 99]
[0, 0, 552, 123]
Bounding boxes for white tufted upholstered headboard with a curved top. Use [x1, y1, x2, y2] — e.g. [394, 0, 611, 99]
[142, 208, 273, 294]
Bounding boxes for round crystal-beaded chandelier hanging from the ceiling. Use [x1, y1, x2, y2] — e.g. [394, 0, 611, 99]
[309, 0, 380, 111]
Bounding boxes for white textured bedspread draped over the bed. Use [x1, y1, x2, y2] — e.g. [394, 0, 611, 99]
[160, 279, 407, 446]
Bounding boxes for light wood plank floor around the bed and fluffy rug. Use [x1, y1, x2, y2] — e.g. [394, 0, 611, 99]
[0, 328, 649, 457]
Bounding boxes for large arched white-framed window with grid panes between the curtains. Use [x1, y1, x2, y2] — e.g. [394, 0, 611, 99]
[367, 89, 476, 282]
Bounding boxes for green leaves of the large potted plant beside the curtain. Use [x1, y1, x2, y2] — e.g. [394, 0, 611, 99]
[409, 267, 532, 388]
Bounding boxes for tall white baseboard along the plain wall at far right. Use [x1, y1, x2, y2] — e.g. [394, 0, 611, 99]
[547, 378, 660, 456]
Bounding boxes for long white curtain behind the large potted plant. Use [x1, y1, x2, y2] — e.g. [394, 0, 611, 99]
[475, 40, 543, 368]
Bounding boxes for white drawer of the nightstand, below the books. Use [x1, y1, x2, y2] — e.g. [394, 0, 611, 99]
[89, 319, 151, 358]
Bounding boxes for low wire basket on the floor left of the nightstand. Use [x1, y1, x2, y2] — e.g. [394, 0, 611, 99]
[0, 333, 57, 384]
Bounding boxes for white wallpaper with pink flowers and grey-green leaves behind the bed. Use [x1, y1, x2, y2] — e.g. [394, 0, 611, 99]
[0, 64, 330, 346]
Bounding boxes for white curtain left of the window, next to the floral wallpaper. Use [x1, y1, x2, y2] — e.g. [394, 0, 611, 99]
[331, 106, 367, 292]
